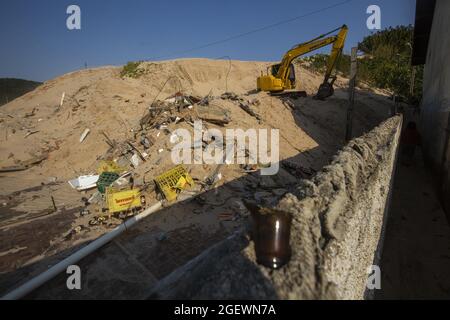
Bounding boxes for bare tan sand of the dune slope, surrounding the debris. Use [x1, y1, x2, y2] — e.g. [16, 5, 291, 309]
[0, 59, 389, 280]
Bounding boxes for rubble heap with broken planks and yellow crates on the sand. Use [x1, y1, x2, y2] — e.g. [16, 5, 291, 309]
[60, 92, 305, 239]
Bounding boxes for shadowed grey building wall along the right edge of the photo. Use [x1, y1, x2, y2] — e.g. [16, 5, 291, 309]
[420, 0, 450, 212]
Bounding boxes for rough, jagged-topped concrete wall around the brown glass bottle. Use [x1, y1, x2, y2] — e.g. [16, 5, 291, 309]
[149, 116, 402, 299]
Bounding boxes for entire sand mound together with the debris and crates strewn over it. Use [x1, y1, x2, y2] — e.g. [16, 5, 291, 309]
[0, 59, 390, 282]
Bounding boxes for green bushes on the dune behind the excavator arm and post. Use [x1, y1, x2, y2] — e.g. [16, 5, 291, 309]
[300, 26, 423, 103]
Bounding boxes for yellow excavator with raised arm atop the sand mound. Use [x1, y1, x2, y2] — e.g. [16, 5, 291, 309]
[257, 24, 348, 100]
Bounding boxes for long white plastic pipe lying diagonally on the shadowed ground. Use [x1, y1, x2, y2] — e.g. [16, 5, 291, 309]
[0, 201, 162, 300]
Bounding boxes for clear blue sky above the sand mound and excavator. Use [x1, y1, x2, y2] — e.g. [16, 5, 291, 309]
[0, 0, 415, 81]
